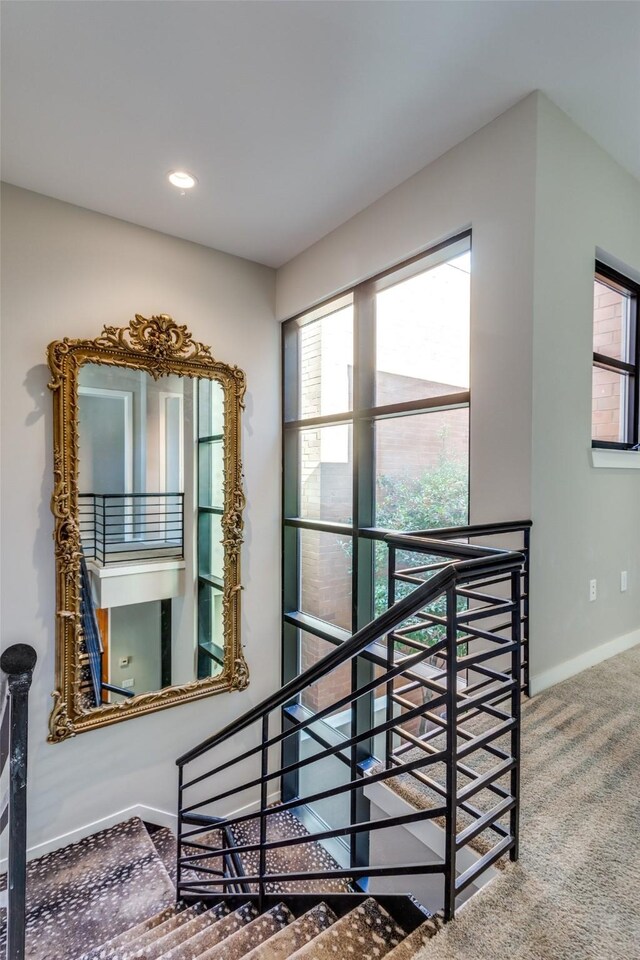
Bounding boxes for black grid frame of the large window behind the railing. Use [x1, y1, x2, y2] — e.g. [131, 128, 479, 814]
[282, 229, 472, 865]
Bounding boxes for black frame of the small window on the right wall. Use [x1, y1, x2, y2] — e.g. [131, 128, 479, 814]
[591, 260, 640, 450]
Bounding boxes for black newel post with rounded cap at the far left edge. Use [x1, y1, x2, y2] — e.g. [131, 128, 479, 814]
[0, 643, 37, 960]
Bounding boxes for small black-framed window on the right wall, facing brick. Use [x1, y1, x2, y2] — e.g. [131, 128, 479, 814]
[591, 261, 640, 450]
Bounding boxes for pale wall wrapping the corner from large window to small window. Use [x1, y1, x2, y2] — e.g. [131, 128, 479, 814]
[276, 93, 640, 689]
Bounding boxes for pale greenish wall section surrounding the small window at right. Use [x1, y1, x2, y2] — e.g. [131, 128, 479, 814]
[532, 97, 640, 687]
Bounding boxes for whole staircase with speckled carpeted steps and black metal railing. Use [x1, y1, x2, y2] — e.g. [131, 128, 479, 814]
[0, 523, 530, 960]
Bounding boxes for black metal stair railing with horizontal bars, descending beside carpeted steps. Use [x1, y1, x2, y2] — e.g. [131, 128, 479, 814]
[177, 535, 525, 919]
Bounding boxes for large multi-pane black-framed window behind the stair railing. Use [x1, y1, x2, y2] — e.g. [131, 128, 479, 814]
[283, 234, 470, 832]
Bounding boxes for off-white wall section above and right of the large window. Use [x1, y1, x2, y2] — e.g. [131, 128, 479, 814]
[276, 95, 537, 523]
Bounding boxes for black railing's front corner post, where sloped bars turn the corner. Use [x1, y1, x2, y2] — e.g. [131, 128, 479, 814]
[444, 583, 458, 921]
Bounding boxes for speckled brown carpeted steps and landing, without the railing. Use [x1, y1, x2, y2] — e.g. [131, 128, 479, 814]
[0, 816, 440, 960]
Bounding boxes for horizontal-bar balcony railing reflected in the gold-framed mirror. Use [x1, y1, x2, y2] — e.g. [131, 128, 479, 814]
[78, 493, 184, 565]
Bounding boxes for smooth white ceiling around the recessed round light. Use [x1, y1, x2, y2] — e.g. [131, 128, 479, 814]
[2, 0, 640, 266]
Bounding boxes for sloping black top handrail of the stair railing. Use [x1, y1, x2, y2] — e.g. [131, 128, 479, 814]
[176, 534, 525, 767]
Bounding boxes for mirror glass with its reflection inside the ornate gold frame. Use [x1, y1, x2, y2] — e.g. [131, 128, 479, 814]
[78, 363, 225, 709]
